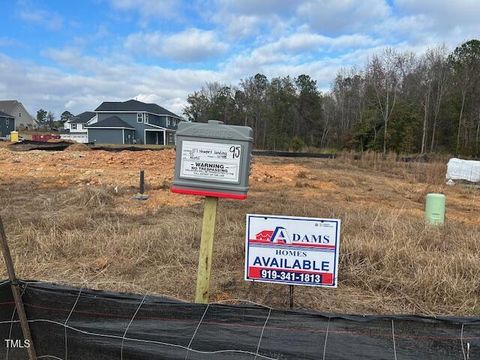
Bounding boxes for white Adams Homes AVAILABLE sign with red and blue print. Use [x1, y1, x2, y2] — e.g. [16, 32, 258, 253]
[245, 214, 340, 288]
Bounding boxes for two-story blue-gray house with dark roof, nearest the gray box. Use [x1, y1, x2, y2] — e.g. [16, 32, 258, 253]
[87, 100, 181, 145]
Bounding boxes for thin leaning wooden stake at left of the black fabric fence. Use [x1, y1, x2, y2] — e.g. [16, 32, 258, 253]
[0, 217, 37, 360]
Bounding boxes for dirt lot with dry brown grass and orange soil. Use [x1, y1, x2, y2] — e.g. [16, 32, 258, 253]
[0, 146, 480, 315]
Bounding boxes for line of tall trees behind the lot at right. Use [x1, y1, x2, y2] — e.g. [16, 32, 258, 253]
[184, 40, 480, 157]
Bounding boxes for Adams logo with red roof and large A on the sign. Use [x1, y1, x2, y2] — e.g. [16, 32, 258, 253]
[255, 226, 330, 244]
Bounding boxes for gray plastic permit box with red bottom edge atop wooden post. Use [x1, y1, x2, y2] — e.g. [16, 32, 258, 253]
[171, 120, 253, 200]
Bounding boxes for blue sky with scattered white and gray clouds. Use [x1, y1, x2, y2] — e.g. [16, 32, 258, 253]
[0, 0, 480, 116]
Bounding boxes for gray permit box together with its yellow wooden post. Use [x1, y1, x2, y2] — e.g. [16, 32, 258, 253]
[170, 120, 253, 303]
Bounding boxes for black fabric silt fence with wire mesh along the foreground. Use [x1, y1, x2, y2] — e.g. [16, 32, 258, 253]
[0, 281, 480, 360]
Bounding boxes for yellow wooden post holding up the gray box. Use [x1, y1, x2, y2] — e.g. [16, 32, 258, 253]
[195, 196, 218, 304]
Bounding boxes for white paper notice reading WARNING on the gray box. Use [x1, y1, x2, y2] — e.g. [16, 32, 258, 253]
[180, 141, 242, 183]
